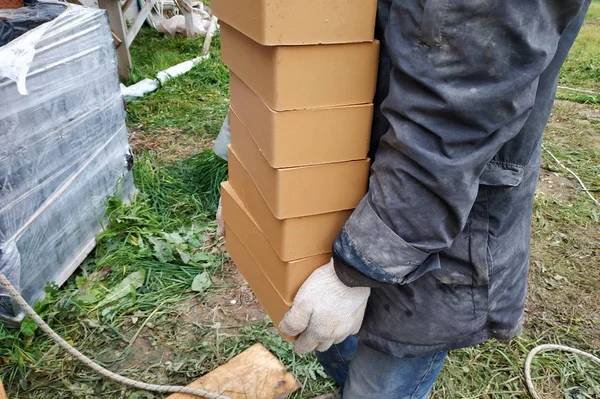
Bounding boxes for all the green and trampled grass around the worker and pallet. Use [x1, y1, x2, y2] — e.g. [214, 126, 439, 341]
[0, 5, 600, 399]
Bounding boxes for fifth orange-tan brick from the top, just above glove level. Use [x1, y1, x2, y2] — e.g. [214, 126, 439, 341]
[229, 147, 352, 261]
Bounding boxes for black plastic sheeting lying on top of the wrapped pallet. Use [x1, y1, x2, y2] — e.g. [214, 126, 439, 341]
[0, 0, 67, 47]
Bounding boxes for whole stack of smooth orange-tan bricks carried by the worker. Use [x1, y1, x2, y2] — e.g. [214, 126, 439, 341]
[212, 0, 379, 338]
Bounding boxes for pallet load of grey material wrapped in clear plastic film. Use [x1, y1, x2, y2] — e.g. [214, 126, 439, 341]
[0, 6, 134, 323]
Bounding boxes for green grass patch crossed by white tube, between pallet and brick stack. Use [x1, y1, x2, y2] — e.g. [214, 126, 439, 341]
[127, 28, 229, 136]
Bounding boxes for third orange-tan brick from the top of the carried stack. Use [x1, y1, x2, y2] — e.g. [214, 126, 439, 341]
[230, 73, 373, 168]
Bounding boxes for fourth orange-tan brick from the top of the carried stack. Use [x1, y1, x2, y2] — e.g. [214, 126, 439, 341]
[230, 119, 370, 219]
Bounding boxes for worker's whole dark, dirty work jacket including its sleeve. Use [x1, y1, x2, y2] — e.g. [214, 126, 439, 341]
[333, 0, 589, 357]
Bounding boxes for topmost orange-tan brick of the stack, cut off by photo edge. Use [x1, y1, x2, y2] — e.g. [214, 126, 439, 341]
[212, 0, 377, 46]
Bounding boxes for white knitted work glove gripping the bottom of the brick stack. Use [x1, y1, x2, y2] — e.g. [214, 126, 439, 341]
[279, 259, 371, 354]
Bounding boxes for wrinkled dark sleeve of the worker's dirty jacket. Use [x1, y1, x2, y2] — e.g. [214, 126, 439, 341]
[333, 0, 587, 286]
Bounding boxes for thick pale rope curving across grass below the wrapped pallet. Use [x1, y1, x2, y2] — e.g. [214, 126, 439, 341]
[0, 273, 230, 399]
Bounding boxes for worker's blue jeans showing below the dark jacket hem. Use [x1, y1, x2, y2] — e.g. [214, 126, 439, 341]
[316, 336, 446, 399]
